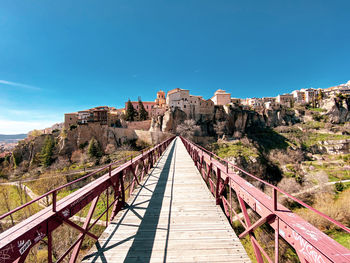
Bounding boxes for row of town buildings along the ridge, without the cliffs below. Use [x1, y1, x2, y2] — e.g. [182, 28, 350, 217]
[64, 81, 350, 129]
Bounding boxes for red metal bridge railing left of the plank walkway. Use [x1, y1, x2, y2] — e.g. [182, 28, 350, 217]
[0, 137, 174, 263]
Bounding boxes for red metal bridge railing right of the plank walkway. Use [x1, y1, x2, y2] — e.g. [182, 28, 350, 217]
[181, 137, 350, 263]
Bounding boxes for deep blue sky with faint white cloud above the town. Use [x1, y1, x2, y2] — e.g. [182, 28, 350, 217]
[0, 0, 350, 134]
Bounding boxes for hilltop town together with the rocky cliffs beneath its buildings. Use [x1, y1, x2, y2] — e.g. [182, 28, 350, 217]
[0, 81, 350, 163]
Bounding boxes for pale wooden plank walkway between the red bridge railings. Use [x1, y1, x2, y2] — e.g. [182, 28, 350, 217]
[83, 138, 251, 263]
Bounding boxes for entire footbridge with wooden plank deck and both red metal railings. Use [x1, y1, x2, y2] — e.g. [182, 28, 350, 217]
[0, 137, 350, 263]
